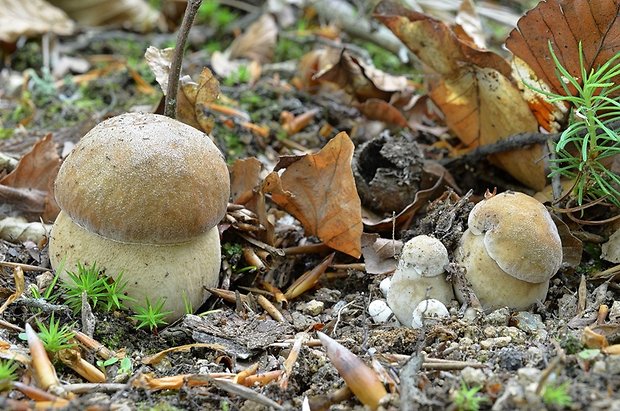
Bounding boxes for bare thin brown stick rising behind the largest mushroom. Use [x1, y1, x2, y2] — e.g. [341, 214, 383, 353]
[164, 0, 202, 118]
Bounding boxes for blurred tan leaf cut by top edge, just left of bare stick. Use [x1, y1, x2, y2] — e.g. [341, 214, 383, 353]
[49, 0, 159, 33]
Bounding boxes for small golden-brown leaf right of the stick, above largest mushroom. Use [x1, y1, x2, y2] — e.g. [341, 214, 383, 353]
[177, 67, 220, 134]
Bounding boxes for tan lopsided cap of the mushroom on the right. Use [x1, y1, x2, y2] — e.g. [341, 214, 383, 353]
[468, 192, 562, 283]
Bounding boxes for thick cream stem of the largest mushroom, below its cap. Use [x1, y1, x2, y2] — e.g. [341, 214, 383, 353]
[49, 212, 220, 322]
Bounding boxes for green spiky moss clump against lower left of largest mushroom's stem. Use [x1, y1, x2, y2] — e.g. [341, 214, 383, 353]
[58, 262, 130, 312]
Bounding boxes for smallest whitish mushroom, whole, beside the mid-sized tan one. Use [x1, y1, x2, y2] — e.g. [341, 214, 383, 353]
[387, 235, 454, 325]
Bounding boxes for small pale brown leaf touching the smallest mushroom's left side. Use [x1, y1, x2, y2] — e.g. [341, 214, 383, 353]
[362, 233, 403, 274]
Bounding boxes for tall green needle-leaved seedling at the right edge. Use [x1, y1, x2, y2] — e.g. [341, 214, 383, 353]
[532, 42, 620, 206]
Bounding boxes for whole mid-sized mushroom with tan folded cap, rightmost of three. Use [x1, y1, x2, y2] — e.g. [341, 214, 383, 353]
[455, 192, 562, 310]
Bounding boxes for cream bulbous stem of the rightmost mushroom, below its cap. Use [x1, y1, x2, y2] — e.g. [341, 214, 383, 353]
[455, 229, 549, 310]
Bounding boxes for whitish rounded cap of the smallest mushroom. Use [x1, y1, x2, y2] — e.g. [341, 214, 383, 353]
[396, 235, 450, 277]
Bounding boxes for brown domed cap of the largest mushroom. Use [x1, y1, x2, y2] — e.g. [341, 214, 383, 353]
[55, 113, 230, 244]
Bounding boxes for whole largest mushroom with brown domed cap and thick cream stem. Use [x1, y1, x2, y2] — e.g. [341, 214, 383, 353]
[49, 113, 230, 321]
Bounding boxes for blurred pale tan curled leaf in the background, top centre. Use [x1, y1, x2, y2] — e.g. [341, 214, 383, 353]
[228, 14, 278, 64]
